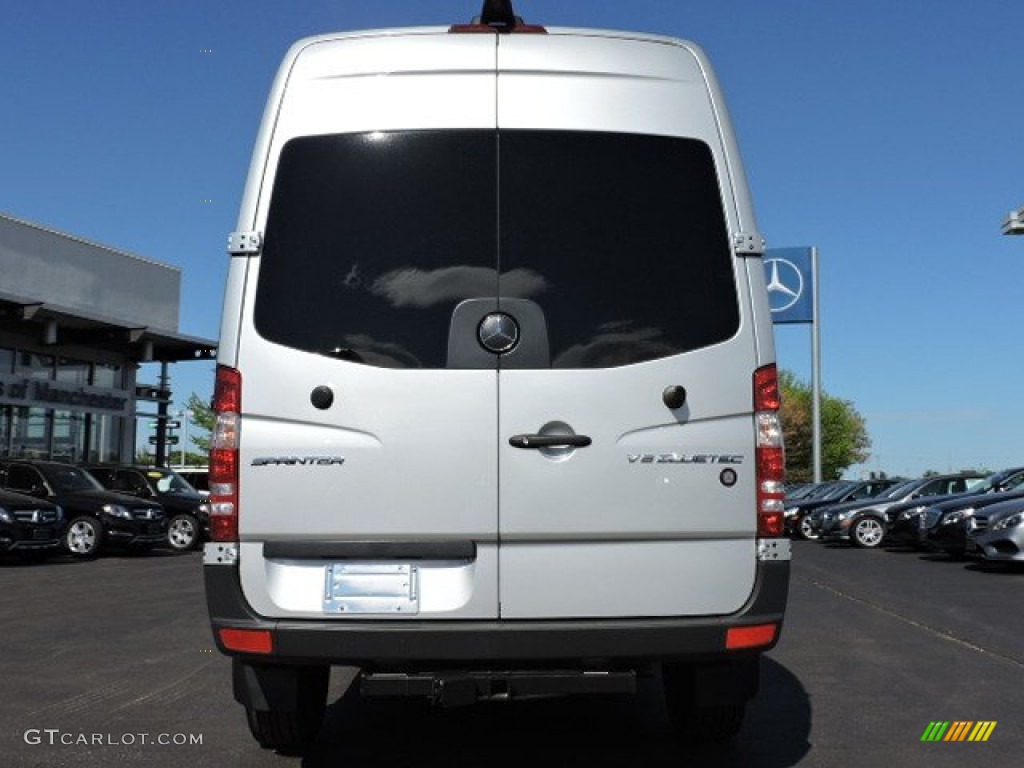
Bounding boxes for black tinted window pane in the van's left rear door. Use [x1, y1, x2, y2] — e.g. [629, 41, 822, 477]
[255, 131, 498, 368]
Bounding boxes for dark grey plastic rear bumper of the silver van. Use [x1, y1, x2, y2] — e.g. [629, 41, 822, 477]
[204, 560, 790, 669]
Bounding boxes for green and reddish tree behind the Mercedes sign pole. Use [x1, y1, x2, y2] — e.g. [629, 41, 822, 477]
[779, 371, 871, 482]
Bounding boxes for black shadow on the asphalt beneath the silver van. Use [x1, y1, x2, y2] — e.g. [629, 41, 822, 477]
[301, 658, 811, 768]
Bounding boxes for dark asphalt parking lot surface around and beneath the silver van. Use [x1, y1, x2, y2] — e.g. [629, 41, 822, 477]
[0, 542, 1024, 768]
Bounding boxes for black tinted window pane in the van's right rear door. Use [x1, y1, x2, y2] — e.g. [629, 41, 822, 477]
[501, 131, 739, 368]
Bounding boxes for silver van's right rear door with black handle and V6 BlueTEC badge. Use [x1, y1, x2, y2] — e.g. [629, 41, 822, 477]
[498, 35, 756, 618]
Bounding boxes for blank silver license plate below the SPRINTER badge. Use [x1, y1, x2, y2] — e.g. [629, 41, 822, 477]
[324, 562, 420, 614]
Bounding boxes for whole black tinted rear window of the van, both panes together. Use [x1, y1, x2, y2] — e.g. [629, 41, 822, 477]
[255, 130, 739, 368]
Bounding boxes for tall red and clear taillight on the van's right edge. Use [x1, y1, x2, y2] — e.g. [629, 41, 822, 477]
[754, 365, 785, 539]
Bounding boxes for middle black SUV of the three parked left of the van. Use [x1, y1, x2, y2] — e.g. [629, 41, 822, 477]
[0, 459, 167, 557]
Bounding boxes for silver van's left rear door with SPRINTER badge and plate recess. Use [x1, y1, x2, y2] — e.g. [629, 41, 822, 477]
[233, 32, 498, 618]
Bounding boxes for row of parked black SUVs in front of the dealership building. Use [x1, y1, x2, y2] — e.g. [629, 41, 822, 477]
[0, 459, 210, 558]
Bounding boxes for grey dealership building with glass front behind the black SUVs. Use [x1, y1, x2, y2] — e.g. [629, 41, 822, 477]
[0, 214, 216, 462]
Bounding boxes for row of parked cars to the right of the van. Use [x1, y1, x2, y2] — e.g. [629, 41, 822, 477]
[785, 467, 1024, 562]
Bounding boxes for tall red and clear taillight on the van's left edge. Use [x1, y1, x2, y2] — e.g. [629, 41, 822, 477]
[210, 366, 242, 542]
